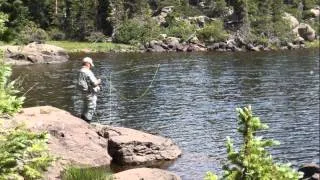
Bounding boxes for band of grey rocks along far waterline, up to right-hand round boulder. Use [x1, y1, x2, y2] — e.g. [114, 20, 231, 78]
[140, 31, 316, 53]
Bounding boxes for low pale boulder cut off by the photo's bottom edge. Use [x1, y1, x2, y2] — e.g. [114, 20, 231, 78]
[112, 168, 181, 180]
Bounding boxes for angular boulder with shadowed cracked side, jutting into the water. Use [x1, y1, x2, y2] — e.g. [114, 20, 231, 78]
[94, 124, 181, 165]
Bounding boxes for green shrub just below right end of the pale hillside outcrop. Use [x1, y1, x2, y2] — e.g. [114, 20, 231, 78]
[197, 21, 228, 42]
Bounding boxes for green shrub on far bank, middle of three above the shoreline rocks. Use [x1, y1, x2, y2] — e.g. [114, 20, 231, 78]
[164, 19, 196, 40]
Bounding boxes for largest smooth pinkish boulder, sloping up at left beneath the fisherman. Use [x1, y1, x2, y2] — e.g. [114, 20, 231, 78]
[11, 106, 111, 180]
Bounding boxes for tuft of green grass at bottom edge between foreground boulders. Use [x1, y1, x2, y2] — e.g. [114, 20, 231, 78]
[62, 167, 112, 180]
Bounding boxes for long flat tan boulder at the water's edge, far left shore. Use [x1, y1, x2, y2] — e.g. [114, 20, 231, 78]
[4, 43, 69, 65]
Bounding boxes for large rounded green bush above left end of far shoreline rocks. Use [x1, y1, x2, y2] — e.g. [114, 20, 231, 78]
[113, 18, 160, 44]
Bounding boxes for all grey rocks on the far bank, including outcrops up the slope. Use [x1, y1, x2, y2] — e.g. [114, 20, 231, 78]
[140, 6, 320, 52]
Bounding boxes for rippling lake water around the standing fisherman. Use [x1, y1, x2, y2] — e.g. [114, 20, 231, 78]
[14, 50, 320, 179]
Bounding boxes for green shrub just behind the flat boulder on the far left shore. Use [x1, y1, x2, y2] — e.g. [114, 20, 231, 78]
[17, 21, 48, 44]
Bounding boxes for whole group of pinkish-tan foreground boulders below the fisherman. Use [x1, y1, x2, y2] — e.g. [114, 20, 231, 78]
[4, 106, 182, 180]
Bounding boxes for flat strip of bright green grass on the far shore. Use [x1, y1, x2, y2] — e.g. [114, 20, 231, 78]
[46, 41, 136, 52]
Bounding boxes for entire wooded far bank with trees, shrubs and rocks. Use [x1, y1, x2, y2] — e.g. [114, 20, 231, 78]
[0, 0, 320, 52]
